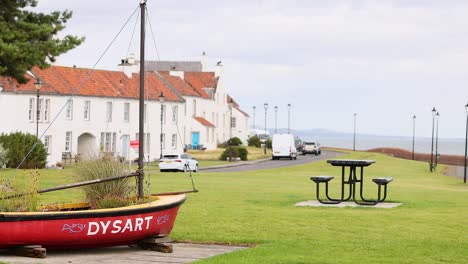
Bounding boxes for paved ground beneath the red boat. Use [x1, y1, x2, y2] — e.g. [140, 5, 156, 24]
[0, 243, 245, 264]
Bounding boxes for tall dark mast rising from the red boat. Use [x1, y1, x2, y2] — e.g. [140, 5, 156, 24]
[137, 0, 146, 198]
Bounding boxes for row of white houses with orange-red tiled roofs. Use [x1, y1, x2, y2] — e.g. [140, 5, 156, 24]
[0, 55, 249, 166]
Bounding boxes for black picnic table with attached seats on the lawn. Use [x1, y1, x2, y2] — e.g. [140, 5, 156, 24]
[310, 159, 393, 205]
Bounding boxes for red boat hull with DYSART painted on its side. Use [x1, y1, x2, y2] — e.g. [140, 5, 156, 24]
[0, 194, 186, 249]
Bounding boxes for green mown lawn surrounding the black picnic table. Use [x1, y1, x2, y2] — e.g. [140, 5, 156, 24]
[3, 152, 468, 263]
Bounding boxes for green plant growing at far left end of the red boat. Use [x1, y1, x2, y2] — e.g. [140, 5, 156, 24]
[0, 170, 39, 212]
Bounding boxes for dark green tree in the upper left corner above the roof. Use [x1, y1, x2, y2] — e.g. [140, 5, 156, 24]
[0, 0, 84, 83]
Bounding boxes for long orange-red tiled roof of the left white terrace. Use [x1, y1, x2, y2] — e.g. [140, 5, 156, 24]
[0, 66, 180, 101]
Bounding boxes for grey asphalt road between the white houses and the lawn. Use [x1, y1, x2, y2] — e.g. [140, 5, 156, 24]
[204, 151, 344, 172]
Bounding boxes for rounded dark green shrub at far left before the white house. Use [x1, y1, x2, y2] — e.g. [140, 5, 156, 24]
[0, 132, 47, 169]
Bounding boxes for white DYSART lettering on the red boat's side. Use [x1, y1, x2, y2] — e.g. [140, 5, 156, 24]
[88, 216, 153, 236]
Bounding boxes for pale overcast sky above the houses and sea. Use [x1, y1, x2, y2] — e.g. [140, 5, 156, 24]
[39, 0, 468, 138]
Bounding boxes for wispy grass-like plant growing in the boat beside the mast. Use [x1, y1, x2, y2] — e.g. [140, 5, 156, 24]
[75, 155, 136, 208]
